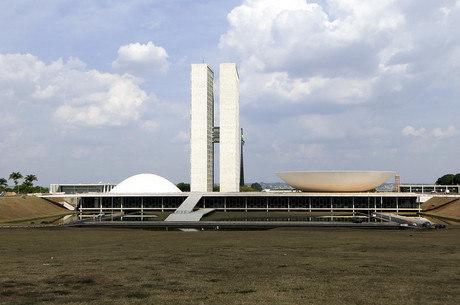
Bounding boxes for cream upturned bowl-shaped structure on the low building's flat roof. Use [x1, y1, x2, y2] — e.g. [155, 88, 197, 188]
[276, 171, 395, 192]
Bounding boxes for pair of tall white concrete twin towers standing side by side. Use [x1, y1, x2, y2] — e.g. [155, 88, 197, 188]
[190, 63, 241, 192]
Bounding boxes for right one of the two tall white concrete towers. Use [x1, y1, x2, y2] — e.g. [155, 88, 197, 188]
[219, 63, 241, 192]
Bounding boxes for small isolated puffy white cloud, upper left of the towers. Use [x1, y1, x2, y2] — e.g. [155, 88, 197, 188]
[112, 41, 170, 75]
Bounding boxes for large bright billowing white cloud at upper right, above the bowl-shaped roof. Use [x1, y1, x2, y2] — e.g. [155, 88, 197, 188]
[219, 0, 460, 105]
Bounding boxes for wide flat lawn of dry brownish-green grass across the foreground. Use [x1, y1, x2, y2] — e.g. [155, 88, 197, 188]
[0, 227, 460, 304]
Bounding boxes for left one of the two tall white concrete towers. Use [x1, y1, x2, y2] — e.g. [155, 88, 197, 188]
[190, 64, 214, 192]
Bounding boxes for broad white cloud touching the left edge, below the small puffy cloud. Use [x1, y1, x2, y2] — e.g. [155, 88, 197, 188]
[0, 54, 148, 127]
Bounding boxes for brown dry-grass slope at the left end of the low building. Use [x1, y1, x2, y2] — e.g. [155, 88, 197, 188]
[0, 196, 71, 223]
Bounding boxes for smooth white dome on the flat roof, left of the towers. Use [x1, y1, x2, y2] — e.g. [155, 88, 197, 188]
[110, 174, 181, 194]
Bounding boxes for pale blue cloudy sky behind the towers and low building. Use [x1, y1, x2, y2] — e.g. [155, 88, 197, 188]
[0, 0, 460, 186]
